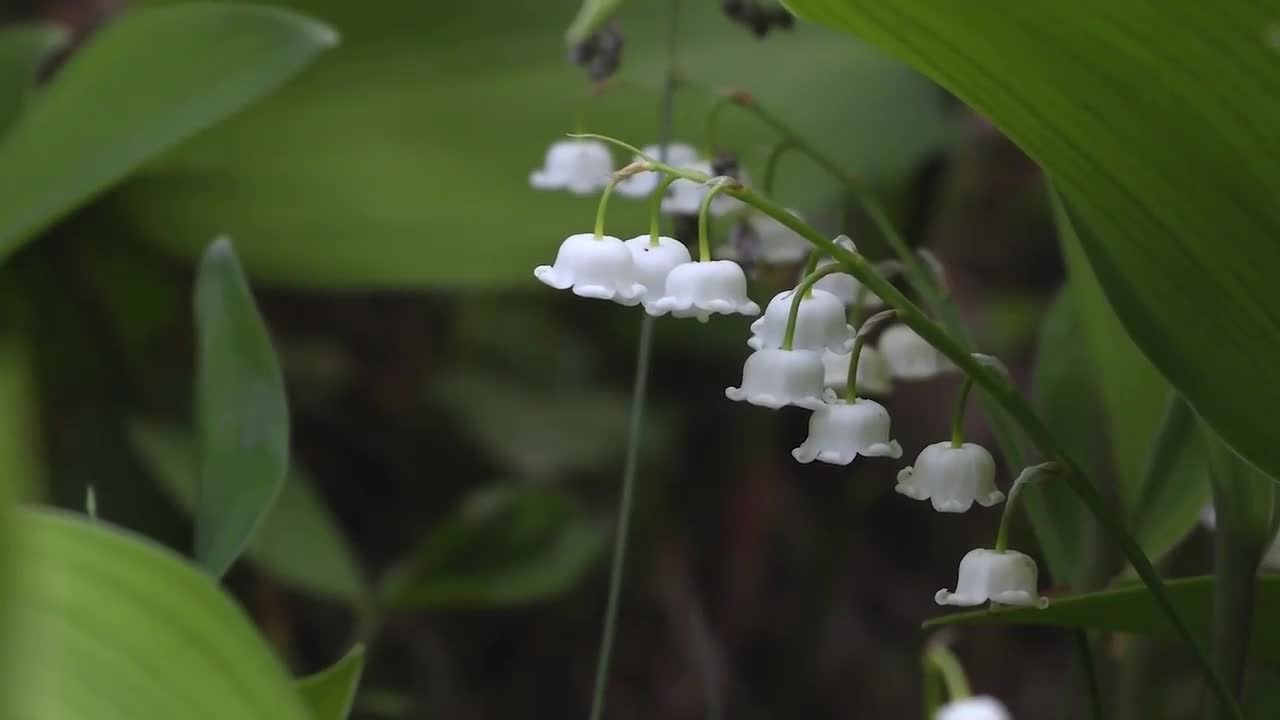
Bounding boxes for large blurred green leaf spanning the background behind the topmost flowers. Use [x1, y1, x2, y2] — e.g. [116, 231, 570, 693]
[118, 0, 952, 285]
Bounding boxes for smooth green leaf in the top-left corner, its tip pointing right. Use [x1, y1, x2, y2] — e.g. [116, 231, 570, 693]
[0, 3, 337, 260]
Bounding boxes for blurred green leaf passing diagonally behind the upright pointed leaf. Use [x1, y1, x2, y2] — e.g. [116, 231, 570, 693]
[129, 423, 367, 606]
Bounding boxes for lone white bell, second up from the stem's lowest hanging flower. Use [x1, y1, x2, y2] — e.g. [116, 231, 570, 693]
[893, 442, 1005, 512]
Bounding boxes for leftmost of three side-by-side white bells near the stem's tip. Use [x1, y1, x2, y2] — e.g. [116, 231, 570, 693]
[534, 233, 645, 305]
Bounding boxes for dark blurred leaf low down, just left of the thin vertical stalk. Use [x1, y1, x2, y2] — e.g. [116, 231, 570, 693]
[381, 486, 605, 609]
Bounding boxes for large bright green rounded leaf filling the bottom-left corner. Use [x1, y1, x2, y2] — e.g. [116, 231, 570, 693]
[0, 509, 310, 720]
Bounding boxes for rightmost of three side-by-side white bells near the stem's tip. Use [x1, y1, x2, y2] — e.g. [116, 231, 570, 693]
[645, 260, 760, 317]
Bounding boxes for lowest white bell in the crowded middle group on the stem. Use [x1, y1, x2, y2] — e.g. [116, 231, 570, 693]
[791, 394, 902, 465]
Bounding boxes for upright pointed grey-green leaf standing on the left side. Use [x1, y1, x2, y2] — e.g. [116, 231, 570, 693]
[195, 238, 289, 577]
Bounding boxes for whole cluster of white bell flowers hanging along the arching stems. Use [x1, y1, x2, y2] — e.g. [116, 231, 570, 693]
[530, 140, 1044, 606]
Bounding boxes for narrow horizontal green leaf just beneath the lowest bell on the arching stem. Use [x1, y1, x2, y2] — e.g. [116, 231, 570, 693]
[924, 575, 1280, 662]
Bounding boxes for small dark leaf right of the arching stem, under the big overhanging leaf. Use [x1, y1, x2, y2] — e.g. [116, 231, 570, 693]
[1129, 396, 1210, 559]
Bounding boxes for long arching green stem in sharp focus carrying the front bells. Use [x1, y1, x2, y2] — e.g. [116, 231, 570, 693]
[570, 136, 1243, 717]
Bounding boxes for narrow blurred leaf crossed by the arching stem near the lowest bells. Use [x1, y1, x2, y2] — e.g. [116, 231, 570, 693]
[1021, 288, 1106, 588]
